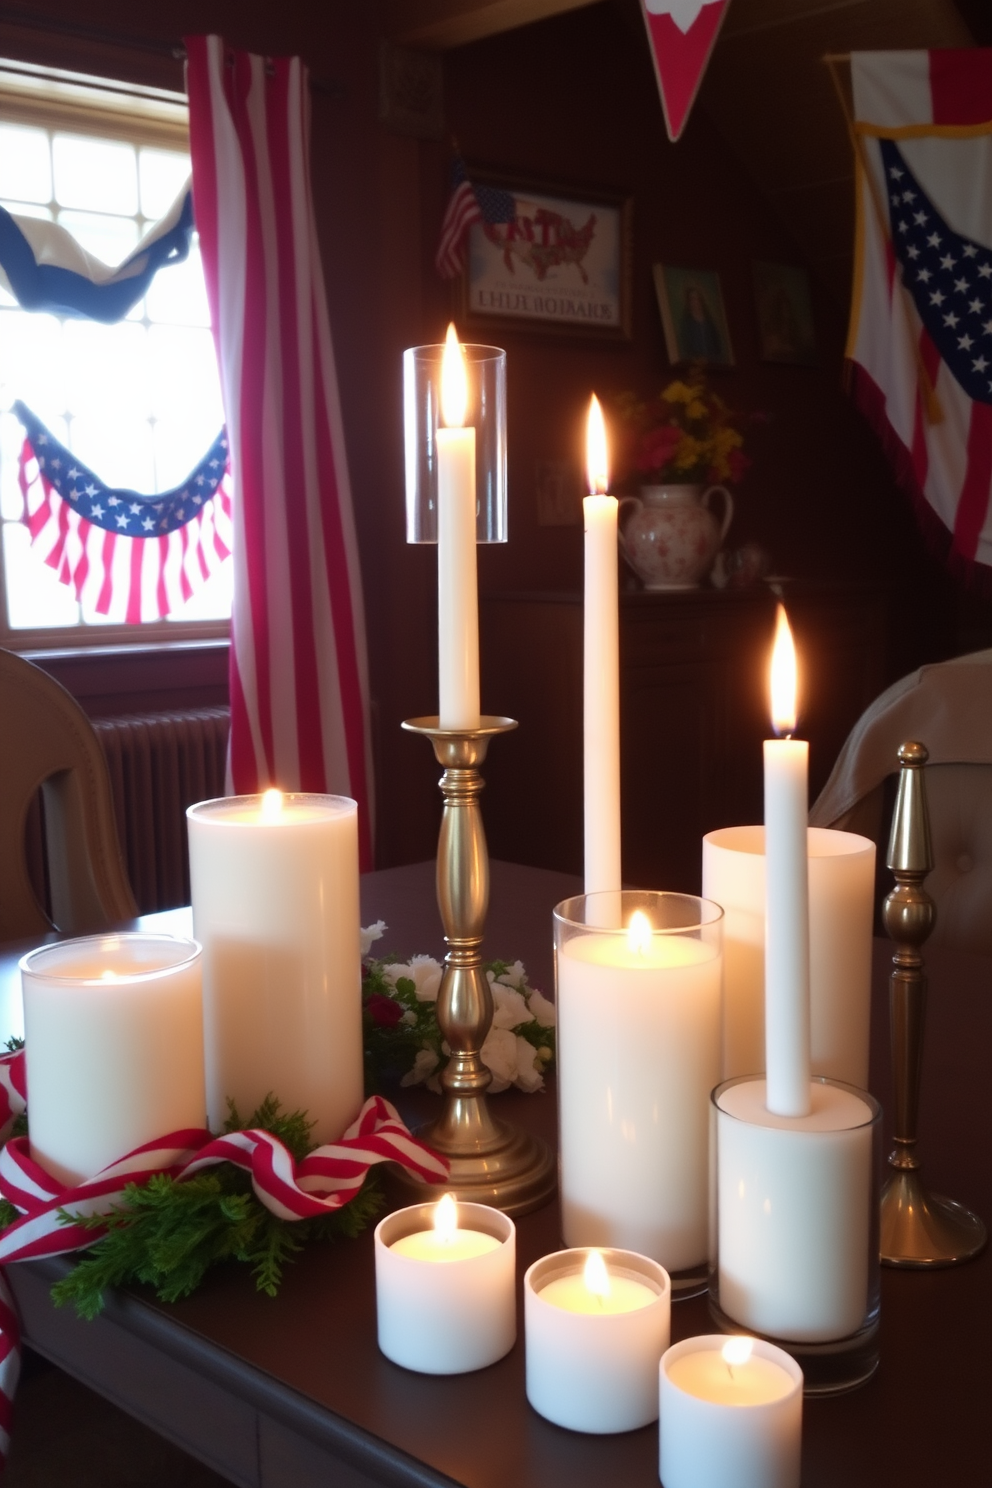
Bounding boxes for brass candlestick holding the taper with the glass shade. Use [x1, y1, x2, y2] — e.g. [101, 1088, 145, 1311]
[396, 716, 558, 1214]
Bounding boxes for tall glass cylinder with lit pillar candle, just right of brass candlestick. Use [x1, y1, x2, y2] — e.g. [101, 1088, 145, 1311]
[555, 890, 723, 1298]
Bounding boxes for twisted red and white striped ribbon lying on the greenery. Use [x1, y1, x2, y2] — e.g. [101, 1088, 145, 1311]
[0, 1051, 448, 1463]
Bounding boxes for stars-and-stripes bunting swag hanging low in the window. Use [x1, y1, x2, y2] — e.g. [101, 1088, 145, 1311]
[13, 402, 232, 625]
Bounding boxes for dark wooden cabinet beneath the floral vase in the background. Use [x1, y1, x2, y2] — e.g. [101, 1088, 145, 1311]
[482, 585, 888, 893]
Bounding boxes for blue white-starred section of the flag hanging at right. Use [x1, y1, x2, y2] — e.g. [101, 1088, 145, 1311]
[879, 140, 992, 403]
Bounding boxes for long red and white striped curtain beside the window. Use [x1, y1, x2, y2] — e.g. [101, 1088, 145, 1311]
[186, 36, 372, 868]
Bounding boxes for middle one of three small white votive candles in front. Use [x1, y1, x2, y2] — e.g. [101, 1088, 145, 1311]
[524, 1250, 671, 1434]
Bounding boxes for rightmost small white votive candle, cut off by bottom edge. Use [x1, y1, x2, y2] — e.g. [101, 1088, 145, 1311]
[657, 1333, 803, 1488]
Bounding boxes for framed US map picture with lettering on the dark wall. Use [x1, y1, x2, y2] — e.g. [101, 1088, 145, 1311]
[461, 168, 632, 341]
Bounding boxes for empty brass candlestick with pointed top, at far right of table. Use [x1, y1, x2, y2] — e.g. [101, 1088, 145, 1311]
[880, 744, 986, 1268]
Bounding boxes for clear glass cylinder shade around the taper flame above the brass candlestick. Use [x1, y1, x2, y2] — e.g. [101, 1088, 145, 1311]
[403, 344, 507, 543]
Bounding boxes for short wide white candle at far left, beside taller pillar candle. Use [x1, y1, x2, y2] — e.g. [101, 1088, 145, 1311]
[21, 934, 205, 1184]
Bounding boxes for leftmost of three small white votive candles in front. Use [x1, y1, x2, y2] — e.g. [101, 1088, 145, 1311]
[375, 1198, 516, 1375]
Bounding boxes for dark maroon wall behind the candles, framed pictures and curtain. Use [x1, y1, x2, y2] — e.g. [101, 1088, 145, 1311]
[0, 0, 989, 866]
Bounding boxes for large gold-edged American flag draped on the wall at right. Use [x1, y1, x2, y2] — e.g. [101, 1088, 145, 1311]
[848, 49, 992, 567]
